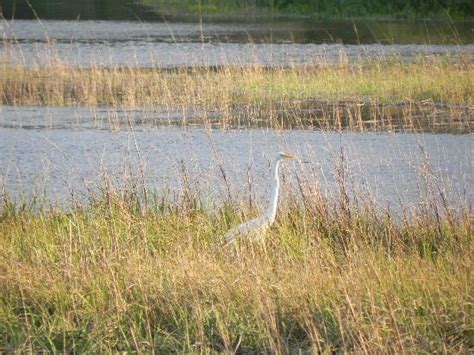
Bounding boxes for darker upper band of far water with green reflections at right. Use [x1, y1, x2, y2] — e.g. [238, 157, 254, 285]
[2, 20, 474, 45]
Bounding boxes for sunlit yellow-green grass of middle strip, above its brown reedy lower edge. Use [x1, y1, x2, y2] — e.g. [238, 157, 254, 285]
[0, 55, 474, 107]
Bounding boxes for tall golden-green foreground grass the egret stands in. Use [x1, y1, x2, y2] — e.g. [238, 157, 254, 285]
[0, 184, 474, 353]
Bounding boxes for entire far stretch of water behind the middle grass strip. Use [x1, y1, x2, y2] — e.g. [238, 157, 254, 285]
[0, 20, 474, 67]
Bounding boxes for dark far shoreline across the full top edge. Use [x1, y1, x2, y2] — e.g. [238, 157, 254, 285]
[0, 0, 474, 19]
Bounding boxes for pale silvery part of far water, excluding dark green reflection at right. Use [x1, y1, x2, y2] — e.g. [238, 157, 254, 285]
[0, 21, 474, 67]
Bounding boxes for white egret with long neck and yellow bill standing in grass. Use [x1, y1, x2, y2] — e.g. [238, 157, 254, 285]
[224, 152, 295, 245]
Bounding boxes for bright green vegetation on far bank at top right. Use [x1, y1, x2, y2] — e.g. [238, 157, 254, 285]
[142, 0, 474, 19]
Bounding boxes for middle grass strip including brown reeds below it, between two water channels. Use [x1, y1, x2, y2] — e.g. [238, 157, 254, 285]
[0, 56, 474, 131]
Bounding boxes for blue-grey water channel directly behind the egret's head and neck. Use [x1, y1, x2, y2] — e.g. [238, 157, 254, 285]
[0, 108, 474, 210]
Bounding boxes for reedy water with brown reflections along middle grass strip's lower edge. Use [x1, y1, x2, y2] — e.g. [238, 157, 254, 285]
[0, 104, 474, 133]
